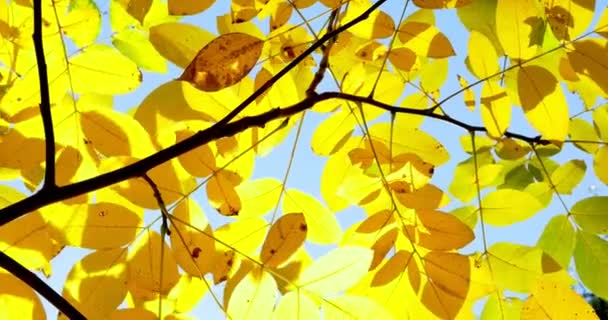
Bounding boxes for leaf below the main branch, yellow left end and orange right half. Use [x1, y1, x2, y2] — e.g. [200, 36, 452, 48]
[49, 202, 143, 250]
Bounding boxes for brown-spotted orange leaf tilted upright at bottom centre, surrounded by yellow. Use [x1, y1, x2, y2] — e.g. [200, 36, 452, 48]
[260, 213, 308, 267]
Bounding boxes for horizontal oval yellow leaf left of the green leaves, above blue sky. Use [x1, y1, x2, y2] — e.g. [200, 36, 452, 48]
[481, 189, 542, 226]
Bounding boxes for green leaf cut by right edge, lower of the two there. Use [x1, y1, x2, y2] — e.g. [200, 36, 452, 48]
[574, 231, 608, 299]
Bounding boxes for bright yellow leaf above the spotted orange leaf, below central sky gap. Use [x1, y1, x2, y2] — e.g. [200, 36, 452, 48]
[236, 178, 283, 218]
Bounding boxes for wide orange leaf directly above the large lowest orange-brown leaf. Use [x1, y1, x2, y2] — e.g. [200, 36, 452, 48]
[417, 210, 475, 250]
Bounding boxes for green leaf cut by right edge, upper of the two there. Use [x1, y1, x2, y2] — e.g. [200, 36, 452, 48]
[570, 196, 608, 234]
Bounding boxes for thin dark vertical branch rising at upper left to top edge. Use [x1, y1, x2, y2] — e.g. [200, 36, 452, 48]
[32, 0, 57, 189]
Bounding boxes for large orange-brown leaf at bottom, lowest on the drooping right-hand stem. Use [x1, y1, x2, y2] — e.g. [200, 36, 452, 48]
[421, 251, 471, 319]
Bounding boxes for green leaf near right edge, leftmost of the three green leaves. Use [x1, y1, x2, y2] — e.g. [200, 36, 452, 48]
[536, 215, 576, 269]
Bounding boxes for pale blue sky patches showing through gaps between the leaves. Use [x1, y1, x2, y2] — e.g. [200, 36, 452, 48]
[32, 0, 608, 319]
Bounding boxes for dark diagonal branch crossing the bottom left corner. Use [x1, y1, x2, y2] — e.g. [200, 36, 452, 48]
[0, 251, 86, 319]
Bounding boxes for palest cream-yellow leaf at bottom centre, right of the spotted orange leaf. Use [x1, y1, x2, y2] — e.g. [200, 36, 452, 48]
[298, 246, 373, 295]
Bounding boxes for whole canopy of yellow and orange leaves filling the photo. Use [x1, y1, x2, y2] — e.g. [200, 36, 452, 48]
[0, 0, 608, 319]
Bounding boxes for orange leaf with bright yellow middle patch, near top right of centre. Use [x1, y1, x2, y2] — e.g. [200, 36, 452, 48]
[399, 21, 455, 58]
